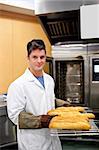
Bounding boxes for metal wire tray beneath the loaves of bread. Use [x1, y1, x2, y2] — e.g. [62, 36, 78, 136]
[50, 120, 99, 137]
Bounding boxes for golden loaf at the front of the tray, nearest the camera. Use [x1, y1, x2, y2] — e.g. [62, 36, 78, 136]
[49, 116, 91, 130]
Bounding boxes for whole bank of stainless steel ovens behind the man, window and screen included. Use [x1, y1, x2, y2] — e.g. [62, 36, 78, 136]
[52, 43, 99, 116]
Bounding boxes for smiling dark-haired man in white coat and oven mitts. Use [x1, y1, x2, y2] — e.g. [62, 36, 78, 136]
[7, 39, 61, 150]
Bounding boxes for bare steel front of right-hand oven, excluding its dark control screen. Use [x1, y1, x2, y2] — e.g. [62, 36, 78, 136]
[88, 43, 99, 113]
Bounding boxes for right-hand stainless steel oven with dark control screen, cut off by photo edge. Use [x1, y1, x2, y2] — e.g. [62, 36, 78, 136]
[88, 43, 99, 116]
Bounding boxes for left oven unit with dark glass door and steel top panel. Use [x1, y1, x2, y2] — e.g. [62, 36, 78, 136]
[52, 45, 85, 104]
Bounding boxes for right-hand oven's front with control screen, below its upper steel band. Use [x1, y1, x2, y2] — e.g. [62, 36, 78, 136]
[89, 54, 99, 114]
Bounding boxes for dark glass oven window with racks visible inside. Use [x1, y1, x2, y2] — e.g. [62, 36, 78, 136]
[55, 60, 84, 104]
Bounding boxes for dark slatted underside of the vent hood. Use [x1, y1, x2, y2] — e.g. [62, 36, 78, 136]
[39, 10, 80, 45]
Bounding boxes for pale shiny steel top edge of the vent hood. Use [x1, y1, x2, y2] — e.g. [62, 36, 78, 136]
[35, 0, 99, 14]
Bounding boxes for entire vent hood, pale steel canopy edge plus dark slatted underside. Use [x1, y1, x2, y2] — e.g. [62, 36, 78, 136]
[35, 0, 99, 45]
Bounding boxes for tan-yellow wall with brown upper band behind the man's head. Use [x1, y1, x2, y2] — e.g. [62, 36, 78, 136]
[0, 10, 51, 93]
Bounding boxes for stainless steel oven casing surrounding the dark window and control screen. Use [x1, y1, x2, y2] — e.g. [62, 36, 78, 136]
[52, 43, 99, 113]
